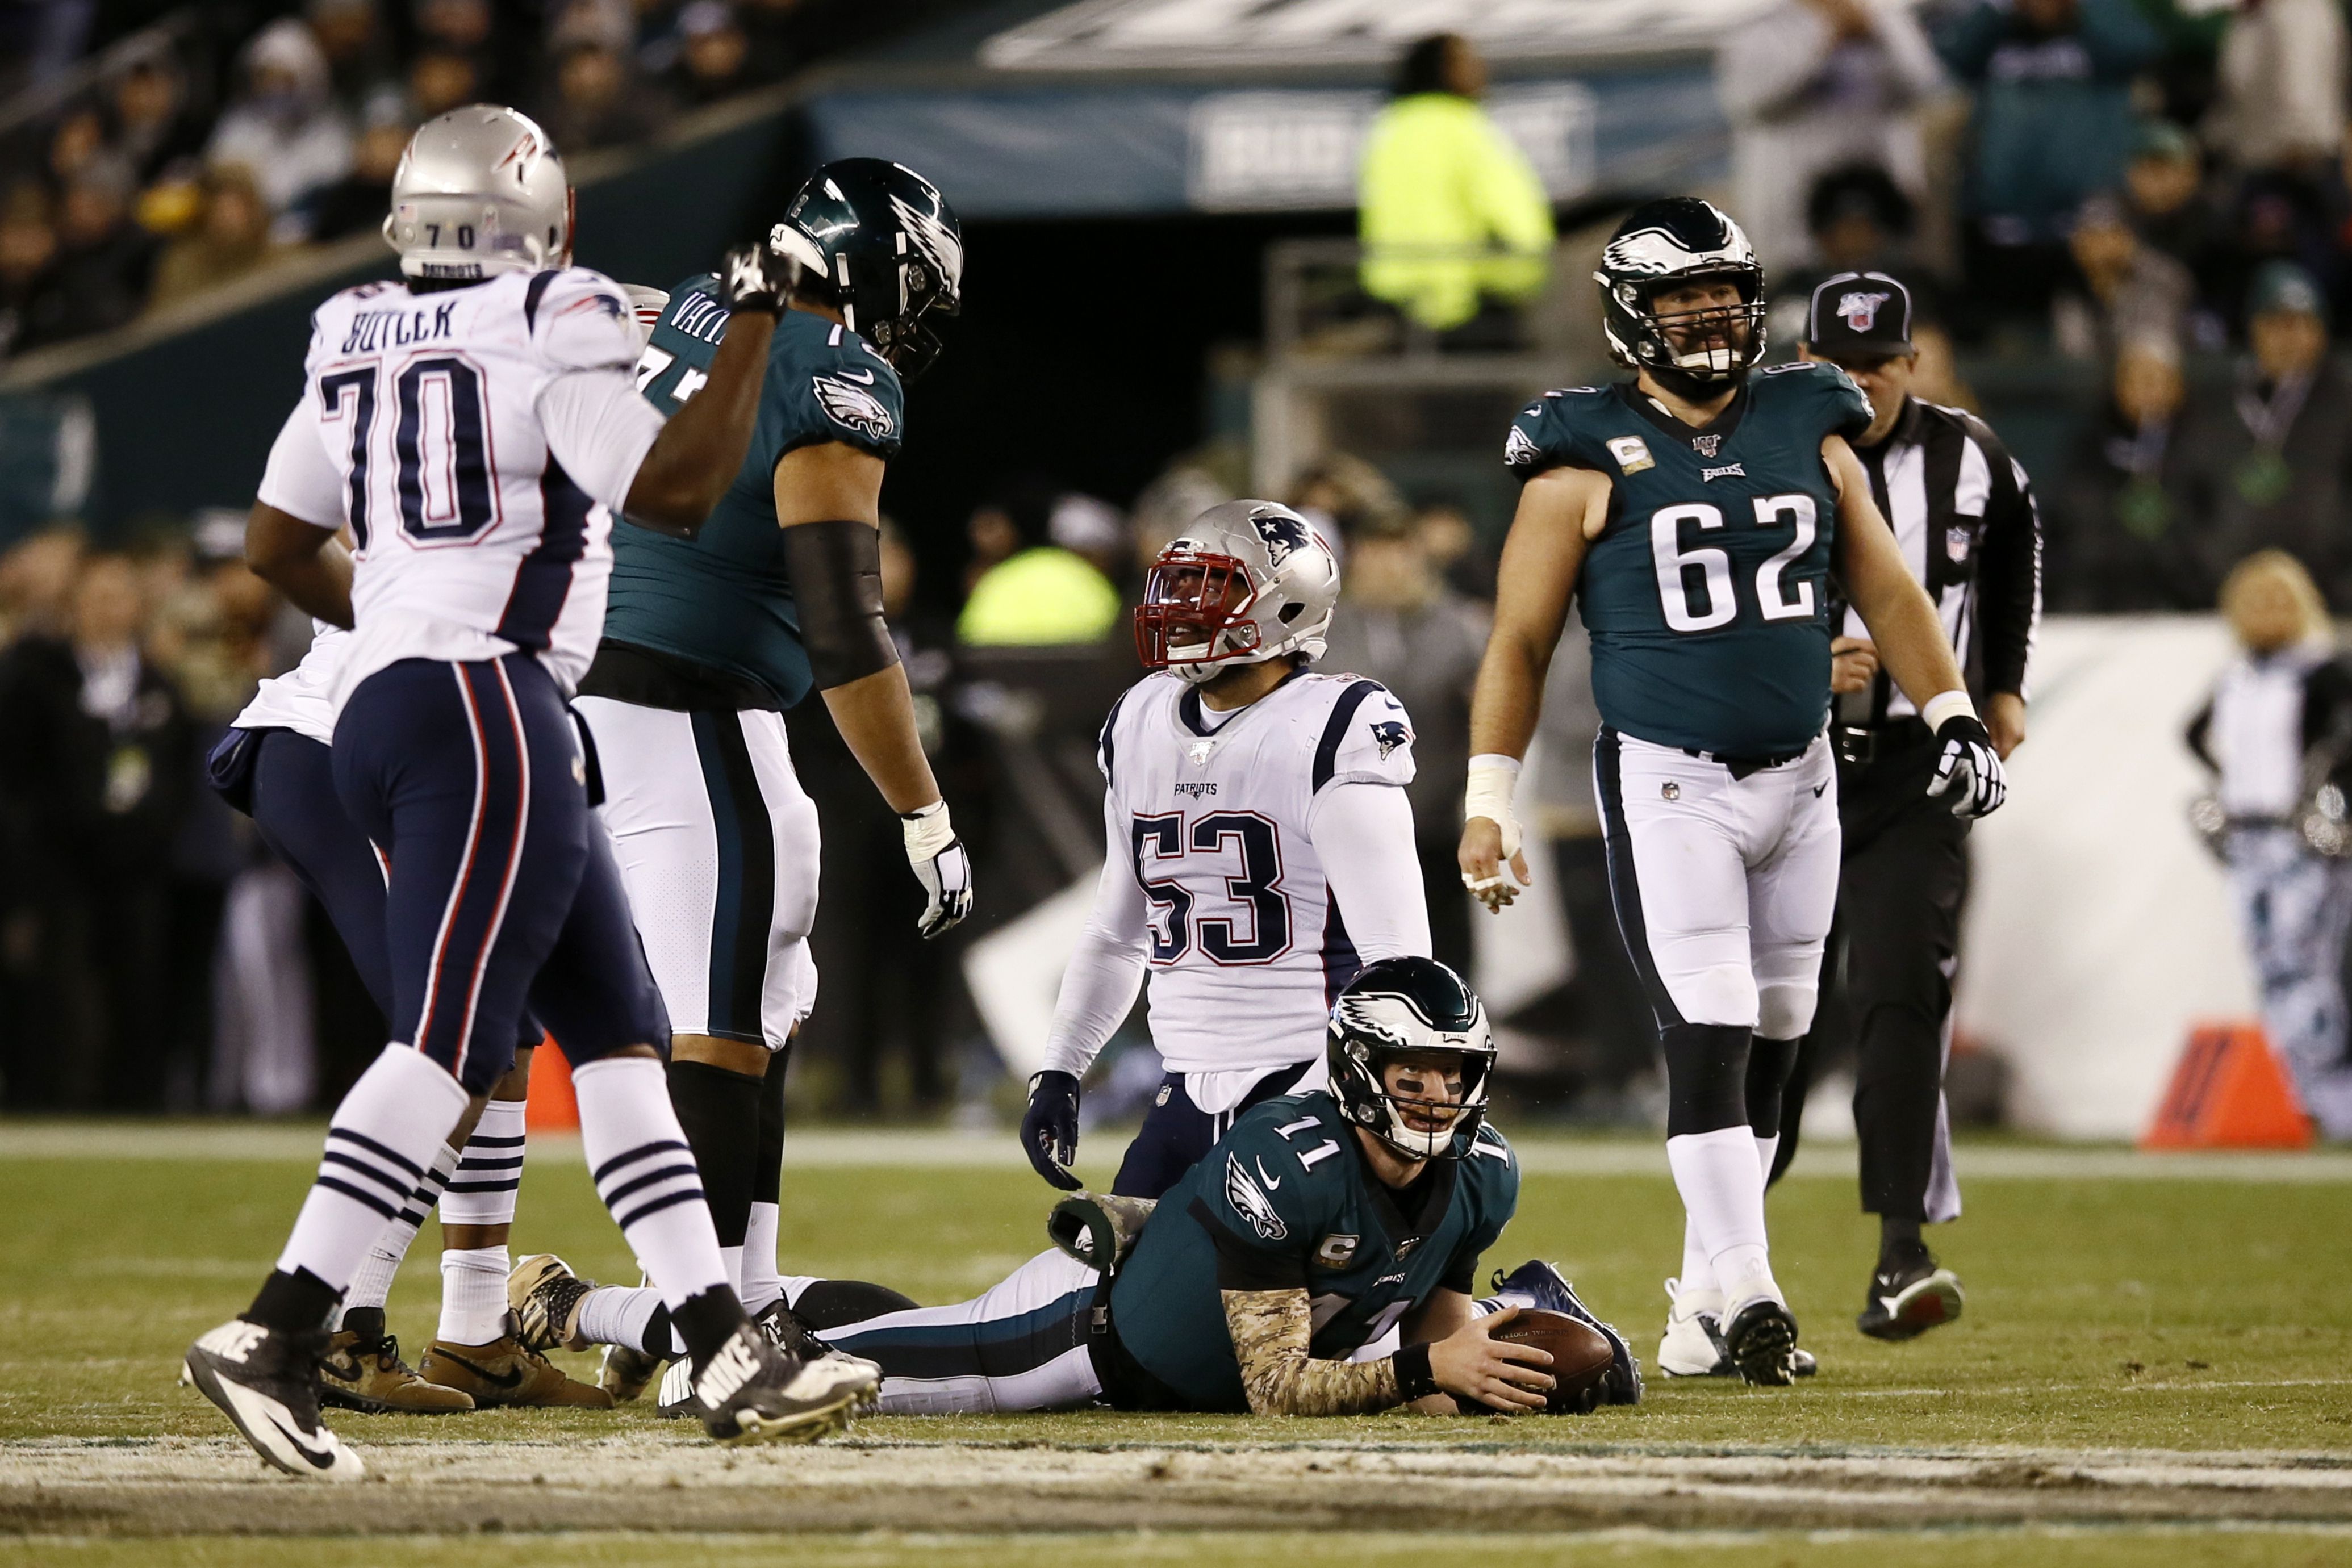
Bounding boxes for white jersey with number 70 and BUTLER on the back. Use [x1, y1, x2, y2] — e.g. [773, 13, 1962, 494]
[261, 268, 658, 708]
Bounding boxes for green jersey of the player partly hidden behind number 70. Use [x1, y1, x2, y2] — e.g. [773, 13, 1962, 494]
[604, 275, 903, 708]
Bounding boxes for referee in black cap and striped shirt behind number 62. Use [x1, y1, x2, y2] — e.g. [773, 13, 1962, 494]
[1773, 273, 2041, 1340]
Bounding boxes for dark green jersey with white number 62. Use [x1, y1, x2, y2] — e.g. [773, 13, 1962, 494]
[1503, 362, 1870, 757]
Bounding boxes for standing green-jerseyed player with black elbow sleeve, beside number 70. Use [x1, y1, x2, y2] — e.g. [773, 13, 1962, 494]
[513, 157, 971, 1399]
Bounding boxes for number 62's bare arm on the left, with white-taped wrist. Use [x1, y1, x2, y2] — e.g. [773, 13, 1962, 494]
[1461, 468, 1609, 910]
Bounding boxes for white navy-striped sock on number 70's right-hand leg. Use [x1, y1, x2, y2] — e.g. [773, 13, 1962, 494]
[571, 1056, 727, 1312]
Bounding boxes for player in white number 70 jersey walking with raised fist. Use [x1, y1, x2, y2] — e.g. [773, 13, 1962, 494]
[186, 103, 872, 1481]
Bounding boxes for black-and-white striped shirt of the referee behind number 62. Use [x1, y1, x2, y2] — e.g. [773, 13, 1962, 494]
[1837, 398, 2041, 724]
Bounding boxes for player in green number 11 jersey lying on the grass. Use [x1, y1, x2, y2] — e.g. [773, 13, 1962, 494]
[531, 957, 1637, 1415]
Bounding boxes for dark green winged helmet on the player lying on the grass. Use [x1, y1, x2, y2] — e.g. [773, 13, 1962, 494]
[1324, 959, 1494, 1159]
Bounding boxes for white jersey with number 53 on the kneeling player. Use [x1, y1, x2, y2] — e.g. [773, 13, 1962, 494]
[1098, 672, 1414, 1072]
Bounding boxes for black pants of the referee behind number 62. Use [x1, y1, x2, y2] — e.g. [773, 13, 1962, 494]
[1773, 736, 1969, 1220]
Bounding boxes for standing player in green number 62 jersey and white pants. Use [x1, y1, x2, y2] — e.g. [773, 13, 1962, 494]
[1461, 198, 2004, 1385]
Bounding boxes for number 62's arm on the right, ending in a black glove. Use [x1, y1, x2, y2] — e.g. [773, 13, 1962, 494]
[1820, 435, 2008, 816]
